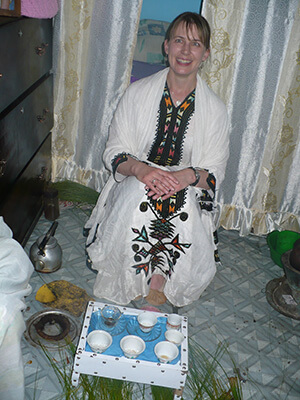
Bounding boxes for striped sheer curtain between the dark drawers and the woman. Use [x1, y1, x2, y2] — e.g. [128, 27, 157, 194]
[52, 0, 142, 191]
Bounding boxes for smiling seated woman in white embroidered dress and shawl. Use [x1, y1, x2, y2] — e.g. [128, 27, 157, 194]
[86, 12, 228, 307]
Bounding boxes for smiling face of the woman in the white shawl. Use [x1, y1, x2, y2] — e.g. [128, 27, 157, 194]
[164, 22, 209, 81]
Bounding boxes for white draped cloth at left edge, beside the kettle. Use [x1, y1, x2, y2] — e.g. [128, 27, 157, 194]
[0, 217, 34, 400]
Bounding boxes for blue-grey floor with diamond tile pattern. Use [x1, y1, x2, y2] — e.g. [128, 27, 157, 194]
[22, 206, 300, 400]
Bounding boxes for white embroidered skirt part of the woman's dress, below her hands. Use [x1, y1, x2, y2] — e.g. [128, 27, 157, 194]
[86, 177, 216, 307]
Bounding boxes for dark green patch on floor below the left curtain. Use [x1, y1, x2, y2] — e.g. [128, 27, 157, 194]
[51, 180, 99, 204]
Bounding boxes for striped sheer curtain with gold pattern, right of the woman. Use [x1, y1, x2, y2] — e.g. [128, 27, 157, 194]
[201, 0, 300, 235]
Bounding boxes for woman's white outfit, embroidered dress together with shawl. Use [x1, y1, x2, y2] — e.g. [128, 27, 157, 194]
[86, 68, 228, 307]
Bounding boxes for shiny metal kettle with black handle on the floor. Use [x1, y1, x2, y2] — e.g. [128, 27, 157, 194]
[29, 221, 62, 273]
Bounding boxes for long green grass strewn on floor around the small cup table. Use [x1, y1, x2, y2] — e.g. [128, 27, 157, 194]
[38, 339, 243, 400]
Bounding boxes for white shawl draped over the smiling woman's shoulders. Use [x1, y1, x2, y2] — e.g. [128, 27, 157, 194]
[86, 68, 229, 239]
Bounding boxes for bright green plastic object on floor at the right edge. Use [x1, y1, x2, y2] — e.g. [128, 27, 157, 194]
[267, 231, 300, 268]
